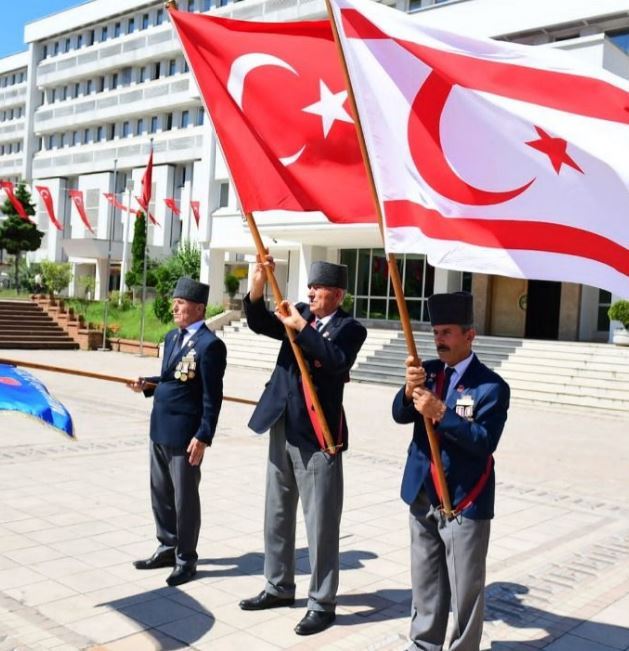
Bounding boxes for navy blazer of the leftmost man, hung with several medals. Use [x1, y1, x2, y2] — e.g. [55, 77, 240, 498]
[144, 325, 227, 448]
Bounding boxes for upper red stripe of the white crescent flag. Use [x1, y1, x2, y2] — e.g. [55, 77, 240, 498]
[342, 9, 629, 124]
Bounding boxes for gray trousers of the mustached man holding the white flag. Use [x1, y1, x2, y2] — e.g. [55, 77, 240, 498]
[409, 490, 491, 651]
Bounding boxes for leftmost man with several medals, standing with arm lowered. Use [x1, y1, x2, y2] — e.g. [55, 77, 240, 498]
[131, 278, 227, 586]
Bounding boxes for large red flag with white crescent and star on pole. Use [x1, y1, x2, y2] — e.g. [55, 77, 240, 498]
[170, 9, 376, 222]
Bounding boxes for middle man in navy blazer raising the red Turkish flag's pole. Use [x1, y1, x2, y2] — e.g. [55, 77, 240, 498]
[240, 256, 367, 635]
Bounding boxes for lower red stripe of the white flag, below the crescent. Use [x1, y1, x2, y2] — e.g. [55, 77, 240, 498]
[384, 200, 629, 276]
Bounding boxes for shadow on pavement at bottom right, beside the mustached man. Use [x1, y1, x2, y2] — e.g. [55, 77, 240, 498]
[485, 582, 629, 651]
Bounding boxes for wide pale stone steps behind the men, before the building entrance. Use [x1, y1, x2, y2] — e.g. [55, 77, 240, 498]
[219, 320, 629, 415]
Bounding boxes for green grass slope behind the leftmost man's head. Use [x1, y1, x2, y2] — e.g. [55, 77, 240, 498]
[64, 299, 223, 344]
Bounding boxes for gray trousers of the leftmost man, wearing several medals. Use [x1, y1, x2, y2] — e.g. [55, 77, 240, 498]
[151, 441, 201, 565]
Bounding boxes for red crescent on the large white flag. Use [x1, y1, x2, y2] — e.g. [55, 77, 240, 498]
[408, 72, 535, 206]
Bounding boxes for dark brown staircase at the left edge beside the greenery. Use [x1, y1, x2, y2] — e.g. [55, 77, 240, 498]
[0, 299, 79, 350]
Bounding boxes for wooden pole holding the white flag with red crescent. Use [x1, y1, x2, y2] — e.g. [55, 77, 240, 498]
[325, 0, 453, 518]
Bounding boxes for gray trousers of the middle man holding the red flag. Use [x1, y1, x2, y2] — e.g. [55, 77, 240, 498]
[264, 418, 343, 611]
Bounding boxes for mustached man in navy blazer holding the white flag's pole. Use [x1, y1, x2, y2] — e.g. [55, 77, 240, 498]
[393, 292, 509, 651]
